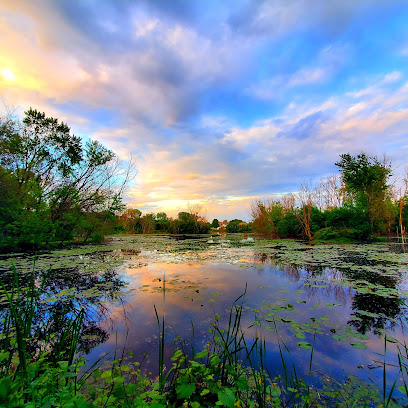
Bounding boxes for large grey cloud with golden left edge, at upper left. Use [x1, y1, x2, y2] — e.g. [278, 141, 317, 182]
[0, 0, 255, 126]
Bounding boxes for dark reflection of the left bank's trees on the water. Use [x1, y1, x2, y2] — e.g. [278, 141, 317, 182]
[0, 267, 125, 354]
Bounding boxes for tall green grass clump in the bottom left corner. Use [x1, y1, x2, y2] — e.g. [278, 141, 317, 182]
[0, 269, 89, 406]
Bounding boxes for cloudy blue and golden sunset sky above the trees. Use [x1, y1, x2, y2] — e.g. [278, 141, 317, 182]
[0, 0, 408, 221]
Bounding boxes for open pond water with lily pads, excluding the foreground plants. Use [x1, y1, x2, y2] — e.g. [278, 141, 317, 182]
[0, 234, 408, 404]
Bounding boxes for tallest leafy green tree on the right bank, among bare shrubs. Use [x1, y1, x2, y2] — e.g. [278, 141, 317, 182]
[335, 152, 392, 233]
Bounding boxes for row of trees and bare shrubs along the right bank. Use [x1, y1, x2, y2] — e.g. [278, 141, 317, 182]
[251, 153, 408, 241]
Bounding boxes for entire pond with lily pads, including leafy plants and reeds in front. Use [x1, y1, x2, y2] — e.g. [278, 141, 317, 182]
[0, 234, 408, 408]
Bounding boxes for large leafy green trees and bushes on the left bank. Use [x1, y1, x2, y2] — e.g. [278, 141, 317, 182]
[0, 109, 134, 252]
